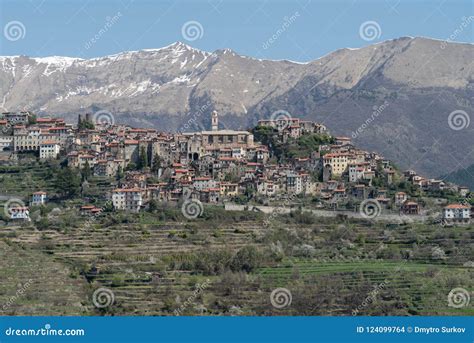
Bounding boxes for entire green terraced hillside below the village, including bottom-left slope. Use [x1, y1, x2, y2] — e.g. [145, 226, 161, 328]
[0, 163, 474, 315]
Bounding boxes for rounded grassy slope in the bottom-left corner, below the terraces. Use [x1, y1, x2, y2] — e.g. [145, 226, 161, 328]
[0, 241, 87, 315]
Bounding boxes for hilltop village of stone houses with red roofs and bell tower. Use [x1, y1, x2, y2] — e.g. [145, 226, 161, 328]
[0, 112, 473, 225]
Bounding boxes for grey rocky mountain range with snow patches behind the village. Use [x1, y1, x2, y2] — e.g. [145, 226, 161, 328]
[0, 38, 474, 176]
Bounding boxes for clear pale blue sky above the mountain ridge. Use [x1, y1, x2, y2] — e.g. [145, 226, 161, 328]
[0, 0, 474, 62]
